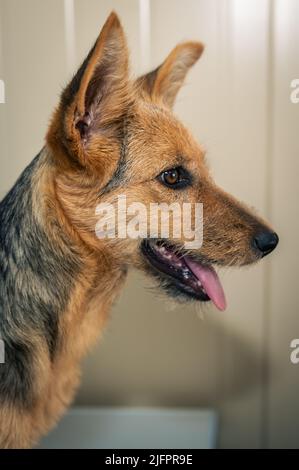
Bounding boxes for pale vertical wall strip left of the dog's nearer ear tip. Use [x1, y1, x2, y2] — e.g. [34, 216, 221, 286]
[64, 0, 76, 75]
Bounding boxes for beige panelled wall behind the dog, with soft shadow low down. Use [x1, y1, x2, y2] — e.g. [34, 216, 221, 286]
[0, 0, 299, 447]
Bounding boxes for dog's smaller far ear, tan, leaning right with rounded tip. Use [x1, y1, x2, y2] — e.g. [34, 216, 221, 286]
[137, 42, 204, 108]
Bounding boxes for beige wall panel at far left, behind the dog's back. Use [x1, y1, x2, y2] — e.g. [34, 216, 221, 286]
[0, 0, 66, 191]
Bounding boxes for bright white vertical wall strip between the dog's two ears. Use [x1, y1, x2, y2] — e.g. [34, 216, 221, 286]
[139, 0, 151, 73]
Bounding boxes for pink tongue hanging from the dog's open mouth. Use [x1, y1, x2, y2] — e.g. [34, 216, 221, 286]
[184, 256, 226, 310]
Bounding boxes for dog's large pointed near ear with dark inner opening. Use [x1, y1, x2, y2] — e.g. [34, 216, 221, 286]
[47, 12, 130, 170]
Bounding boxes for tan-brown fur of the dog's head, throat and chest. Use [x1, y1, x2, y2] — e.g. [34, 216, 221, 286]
[0, 13, 278, 447]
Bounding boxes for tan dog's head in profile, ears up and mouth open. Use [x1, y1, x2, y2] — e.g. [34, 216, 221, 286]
[47, 13, 278, 309]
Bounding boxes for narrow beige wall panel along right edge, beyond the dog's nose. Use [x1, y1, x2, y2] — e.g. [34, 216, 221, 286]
[268, 0, 299, 448]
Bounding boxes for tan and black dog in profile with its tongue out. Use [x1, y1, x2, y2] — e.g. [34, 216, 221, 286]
[0, 12, 278, 448]
